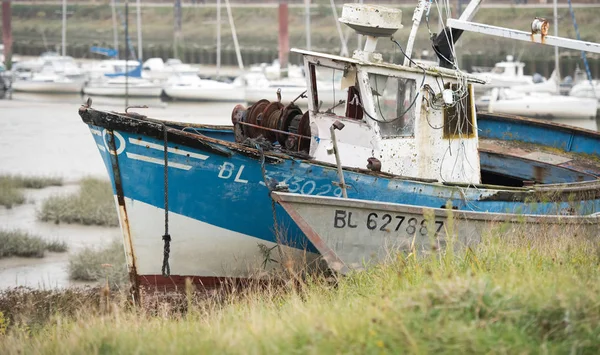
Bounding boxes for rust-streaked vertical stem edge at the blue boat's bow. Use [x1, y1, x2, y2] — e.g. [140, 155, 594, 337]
[107, 130, 140, 303]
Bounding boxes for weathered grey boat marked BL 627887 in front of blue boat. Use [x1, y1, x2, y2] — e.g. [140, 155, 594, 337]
[272, 189, 600, 274]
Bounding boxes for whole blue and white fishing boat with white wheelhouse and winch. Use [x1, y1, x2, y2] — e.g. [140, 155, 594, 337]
[79, 2, 600, 289]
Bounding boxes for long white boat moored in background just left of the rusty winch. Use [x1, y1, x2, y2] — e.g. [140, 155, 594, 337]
[163, 75, 245, 102]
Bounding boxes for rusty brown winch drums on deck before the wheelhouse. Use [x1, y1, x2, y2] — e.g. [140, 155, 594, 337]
[231, 94, 311, 153]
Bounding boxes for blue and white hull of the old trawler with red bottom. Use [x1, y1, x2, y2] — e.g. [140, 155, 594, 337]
[80, 107, 600, 286]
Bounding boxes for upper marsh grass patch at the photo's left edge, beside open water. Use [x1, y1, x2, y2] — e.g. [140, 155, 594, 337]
[0, 175, 63, 208]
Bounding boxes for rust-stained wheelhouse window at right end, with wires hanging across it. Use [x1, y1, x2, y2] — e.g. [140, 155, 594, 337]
[444, 83, 475, 138]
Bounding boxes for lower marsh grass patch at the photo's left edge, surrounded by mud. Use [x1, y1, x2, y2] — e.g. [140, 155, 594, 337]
[0, 230, 67, 259]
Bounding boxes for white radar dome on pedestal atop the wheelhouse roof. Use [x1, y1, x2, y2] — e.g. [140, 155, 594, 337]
[339, 4, 402, 62]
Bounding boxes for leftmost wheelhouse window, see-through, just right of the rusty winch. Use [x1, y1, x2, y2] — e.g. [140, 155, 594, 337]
[310, 65, 357, 118]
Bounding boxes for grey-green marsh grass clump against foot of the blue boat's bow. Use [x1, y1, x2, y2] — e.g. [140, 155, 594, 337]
[69, 240, 128, 287]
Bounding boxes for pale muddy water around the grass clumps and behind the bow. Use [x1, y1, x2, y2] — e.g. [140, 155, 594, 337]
[0, 93, 235, 289]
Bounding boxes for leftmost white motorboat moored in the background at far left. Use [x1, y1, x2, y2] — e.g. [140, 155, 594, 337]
[11, 72, 83, 94]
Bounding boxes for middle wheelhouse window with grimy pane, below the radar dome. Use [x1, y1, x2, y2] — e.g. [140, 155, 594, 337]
[369, 74, 417, 138]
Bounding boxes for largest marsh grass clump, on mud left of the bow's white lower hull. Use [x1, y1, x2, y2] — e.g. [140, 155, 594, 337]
[38, 178, 119, 226]
